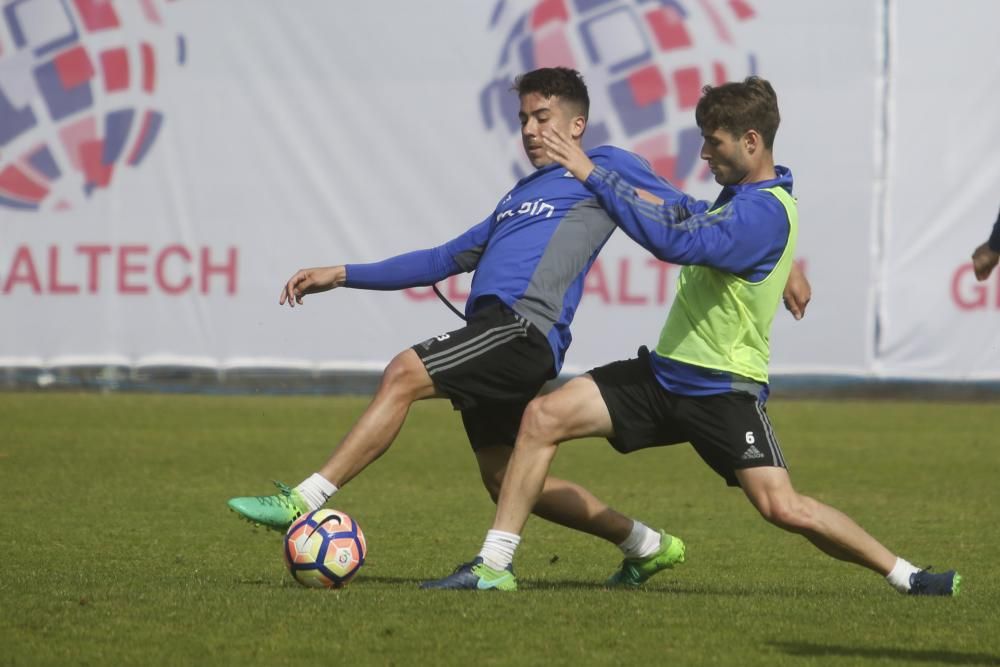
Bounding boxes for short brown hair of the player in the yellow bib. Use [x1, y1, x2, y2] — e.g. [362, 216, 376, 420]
[694, 76, 781, 150]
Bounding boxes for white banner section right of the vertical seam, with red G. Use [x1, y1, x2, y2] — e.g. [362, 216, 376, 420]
[876, 2, 1000, 380]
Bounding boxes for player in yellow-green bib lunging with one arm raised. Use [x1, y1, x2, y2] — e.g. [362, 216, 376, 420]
[424, 77, 961, 596]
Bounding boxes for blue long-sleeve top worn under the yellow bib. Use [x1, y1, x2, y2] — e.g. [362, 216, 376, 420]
[586, 165, 792, 402]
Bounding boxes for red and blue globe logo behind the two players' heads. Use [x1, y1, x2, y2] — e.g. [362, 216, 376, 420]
[480, 0, 757, 187]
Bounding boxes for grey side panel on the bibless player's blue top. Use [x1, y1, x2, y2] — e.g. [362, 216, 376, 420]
[514, 199, 615, 336]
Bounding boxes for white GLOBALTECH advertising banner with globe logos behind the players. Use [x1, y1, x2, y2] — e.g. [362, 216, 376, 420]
[0, 0, 1000, 376]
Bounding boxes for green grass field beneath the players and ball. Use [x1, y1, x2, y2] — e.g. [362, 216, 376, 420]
[0, 393, 1000, 666]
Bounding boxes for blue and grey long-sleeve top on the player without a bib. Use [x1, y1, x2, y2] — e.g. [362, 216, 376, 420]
[345, 146, 684, 372]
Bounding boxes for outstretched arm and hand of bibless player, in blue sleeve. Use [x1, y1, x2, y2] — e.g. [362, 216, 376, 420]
[278, 215, 493, 308]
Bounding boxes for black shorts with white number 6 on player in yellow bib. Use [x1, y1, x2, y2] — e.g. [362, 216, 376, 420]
[590, 347, 787, 486]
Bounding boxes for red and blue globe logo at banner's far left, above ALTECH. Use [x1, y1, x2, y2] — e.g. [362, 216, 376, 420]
[0, 0, 185, 211]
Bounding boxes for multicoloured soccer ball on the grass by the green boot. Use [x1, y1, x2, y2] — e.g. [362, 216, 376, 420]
[285, 509, 368, 588]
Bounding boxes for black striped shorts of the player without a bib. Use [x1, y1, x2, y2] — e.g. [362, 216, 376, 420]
[413, 301, 555, 449]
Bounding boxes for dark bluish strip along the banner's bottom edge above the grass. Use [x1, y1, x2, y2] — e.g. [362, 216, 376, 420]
[0, 365, 1000, 401]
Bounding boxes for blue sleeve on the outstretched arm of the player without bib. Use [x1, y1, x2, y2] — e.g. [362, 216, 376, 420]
[344, 216, 492, 290]
